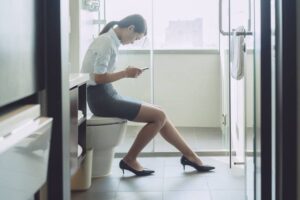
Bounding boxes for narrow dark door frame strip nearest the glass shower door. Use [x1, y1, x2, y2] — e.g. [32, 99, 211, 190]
[255, 0, 272, 200]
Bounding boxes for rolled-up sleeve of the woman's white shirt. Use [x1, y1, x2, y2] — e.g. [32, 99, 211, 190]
[94, 38, 112, 74]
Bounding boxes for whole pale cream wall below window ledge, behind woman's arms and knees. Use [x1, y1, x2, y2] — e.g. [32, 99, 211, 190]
[114, 51, 253, 127]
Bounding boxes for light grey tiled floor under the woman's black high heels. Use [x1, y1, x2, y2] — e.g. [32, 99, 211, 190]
[72, 157, 246, 200]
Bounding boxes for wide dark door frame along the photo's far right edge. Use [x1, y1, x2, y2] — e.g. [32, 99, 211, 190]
[275, 0, 297, 200]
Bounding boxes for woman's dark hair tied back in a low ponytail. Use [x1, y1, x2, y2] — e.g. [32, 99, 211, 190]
[99, 14, 147, 35]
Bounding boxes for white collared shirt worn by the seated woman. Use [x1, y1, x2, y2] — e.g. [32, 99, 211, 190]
[81, 29, 121, 85]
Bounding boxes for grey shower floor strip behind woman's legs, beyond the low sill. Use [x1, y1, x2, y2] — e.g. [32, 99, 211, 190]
[116, 126, 253, 152]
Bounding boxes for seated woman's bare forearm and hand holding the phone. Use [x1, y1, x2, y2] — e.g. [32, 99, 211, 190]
[94, 67, 142, 84]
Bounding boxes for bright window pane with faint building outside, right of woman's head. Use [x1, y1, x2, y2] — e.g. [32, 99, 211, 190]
[153, 0, 219, 49]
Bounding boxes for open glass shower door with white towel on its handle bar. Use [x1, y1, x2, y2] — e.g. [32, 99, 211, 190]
[229, 0, 255, 200]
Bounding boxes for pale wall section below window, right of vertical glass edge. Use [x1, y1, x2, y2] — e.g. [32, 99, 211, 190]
[154, 53, 221, 127]
